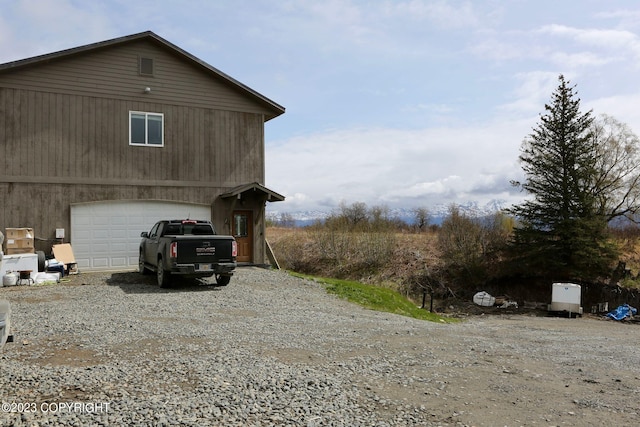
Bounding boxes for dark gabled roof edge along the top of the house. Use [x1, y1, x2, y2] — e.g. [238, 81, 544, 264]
[0, 31, 285, 120]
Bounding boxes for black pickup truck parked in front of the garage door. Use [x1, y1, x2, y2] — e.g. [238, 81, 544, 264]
[138, 219, 238, 288]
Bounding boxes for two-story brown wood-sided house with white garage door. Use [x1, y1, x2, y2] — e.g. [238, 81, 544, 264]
[0, 31, 284, 271]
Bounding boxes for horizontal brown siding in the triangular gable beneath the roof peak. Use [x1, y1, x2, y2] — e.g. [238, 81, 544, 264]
[0, 41, 273, 116]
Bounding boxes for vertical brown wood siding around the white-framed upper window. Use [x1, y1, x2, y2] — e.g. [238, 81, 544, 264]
[0, 87, 264, 187]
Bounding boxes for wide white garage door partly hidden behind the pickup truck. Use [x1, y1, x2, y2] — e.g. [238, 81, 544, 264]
[71, 201, 211, 271]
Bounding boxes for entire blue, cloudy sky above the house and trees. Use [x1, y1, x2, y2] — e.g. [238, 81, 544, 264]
[0, 0, 640, 212]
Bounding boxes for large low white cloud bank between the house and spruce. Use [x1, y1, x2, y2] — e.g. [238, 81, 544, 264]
[267, 122, 529, 211]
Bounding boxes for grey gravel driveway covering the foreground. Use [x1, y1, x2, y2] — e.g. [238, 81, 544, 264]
[0, 267, 640, 426]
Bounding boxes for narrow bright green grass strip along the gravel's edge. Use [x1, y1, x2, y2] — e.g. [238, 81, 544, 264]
[289, 271, 457, 323]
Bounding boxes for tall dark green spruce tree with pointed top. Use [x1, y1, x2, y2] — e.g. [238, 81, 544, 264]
[509, 75, 617, 280]
